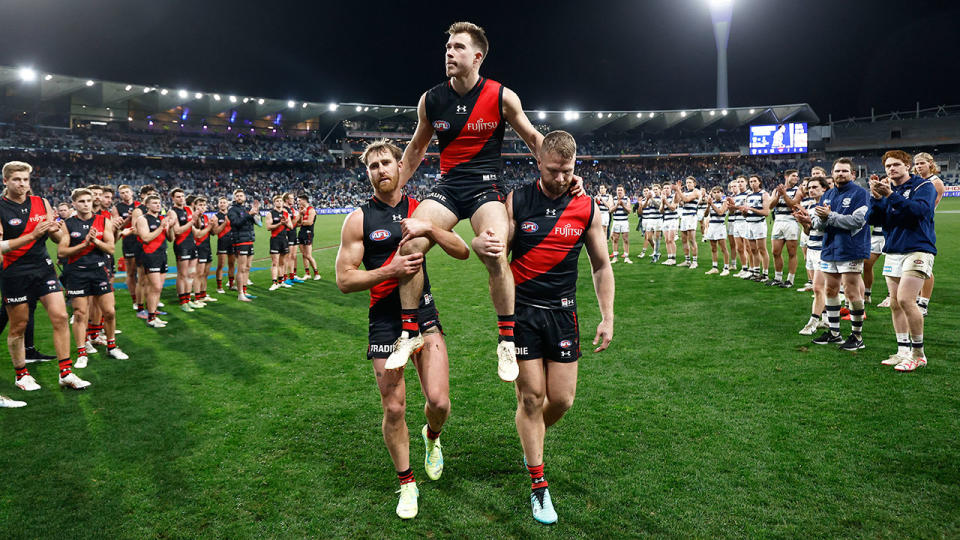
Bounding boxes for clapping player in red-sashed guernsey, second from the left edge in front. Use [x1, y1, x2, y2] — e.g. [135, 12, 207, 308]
[57, 189, 128, 369]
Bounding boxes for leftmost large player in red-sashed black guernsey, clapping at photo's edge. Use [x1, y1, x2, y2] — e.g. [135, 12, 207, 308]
[0, 161, 90, 391]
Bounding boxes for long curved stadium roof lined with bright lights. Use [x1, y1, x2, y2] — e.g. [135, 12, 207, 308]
[0, 66, 820, 133]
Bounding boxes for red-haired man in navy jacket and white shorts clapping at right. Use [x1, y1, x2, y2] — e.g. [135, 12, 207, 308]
[868, 150, 937, 371]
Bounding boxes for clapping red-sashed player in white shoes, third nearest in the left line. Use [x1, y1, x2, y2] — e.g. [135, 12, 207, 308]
[134, 194, 177, 328]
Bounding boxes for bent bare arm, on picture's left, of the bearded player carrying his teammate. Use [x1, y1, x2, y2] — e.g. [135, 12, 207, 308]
[335, 210, 423, 293]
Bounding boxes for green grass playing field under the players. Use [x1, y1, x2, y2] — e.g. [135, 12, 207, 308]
[0, 200, 960, 538]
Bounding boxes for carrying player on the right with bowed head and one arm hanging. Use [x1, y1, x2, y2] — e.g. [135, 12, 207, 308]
[478, 131, 614, 524]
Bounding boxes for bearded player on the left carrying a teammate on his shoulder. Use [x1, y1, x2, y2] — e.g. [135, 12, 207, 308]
[336, 141, 470, 519]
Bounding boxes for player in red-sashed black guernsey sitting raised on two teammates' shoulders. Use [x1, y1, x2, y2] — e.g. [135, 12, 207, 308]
[386, 22, 583, 382]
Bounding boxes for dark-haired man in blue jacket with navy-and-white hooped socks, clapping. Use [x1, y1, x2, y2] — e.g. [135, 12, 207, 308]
[811, 158, 870, 351]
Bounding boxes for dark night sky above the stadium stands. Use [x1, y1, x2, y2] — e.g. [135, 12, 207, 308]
[0, 0, 960, 121]
